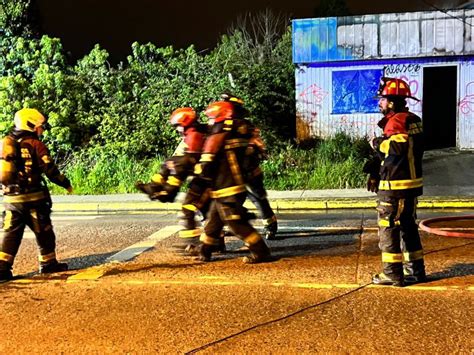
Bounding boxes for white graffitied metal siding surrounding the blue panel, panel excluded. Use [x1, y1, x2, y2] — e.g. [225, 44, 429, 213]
[295, 57, 474, 149]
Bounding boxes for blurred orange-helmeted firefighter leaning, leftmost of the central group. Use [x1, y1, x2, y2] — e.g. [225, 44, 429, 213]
[133, 107, 215, 251]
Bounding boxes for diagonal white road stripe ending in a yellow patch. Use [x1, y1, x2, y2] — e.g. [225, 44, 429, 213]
[67, 225, 183, 282]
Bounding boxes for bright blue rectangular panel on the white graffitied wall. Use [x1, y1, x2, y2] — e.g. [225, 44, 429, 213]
[332, 69, 382, 114]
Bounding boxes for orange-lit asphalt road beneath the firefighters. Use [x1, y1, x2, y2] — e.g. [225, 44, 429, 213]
[0, 210, 474, 354]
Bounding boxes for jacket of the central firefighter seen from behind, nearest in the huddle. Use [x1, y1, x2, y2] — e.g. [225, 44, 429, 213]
[195, 119, 252, 198]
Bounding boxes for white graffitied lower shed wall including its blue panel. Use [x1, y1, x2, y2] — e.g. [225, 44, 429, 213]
[296, 57, 474, 149]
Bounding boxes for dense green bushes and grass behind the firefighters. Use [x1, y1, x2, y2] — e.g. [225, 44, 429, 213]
[0, 6, 366, 193]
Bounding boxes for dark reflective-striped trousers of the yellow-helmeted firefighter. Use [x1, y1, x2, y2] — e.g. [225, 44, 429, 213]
[0, 200, 56, 270]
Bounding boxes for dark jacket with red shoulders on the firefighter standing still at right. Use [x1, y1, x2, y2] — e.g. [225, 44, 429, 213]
[373, 110, 423, 198]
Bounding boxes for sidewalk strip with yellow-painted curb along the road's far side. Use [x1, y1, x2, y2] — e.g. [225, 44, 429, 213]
[40, 186, 474, 214]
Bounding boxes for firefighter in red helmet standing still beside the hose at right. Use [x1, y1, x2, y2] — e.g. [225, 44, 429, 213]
[366, 77, 426, 286]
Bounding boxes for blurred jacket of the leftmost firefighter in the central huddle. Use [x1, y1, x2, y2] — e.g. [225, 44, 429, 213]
[152, 124, 207, 202]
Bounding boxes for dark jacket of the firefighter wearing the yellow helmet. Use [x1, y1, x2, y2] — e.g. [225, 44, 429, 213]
[2, 129, 71, 203]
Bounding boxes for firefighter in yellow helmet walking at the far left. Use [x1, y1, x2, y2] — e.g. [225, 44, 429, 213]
[0, 108, 72, 281]
